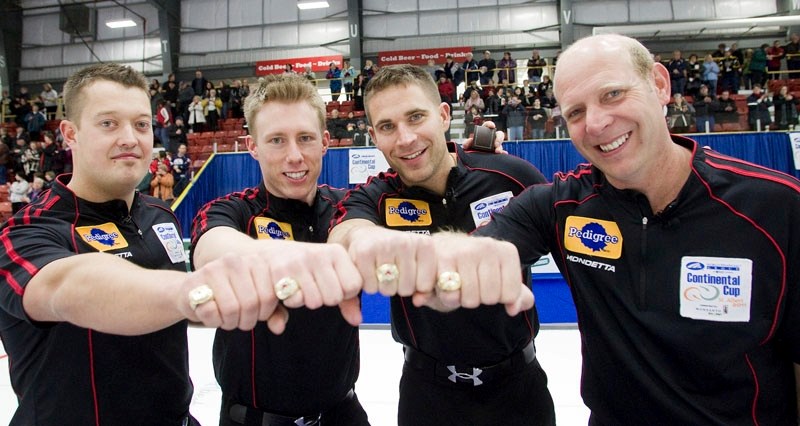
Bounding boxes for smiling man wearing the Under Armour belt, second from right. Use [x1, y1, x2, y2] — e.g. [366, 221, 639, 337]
[329, 65, 555, 426]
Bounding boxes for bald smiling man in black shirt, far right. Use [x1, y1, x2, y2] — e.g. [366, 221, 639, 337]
[472, 35, 800, 425]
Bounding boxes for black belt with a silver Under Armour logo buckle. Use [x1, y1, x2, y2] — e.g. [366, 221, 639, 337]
[404, 340, 536, 386]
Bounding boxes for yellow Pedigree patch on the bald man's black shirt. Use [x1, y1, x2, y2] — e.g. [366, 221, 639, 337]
[564, 216, 622, 259]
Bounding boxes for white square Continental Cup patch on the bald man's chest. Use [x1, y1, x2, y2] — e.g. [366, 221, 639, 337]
[679, 256, 753, 322]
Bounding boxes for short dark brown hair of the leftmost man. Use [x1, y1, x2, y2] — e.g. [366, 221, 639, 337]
[63, 63, 150, 123]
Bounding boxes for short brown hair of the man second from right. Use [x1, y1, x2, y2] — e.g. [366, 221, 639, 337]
[364, 64, 442, 123]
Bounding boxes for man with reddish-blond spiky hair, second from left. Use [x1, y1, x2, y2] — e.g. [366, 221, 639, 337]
[192, 74, 369, 426]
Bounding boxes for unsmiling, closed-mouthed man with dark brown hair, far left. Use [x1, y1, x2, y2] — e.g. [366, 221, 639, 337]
[0, 64, 359, 426]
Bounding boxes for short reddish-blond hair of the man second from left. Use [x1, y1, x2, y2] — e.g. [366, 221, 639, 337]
[244, 73, 325, 135]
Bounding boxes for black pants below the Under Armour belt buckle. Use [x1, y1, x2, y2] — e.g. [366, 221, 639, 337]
[397, 360, 556, 426]
